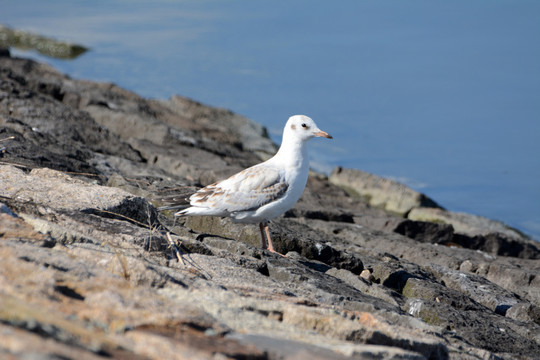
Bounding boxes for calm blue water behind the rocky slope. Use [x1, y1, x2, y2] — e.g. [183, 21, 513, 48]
[0, 0, 540, 239]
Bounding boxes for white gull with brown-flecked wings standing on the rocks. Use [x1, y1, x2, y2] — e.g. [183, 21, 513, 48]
[174, 115, 332, 255]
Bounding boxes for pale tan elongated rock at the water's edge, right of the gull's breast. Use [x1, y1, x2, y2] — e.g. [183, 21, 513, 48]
[329, 167, 439, 215]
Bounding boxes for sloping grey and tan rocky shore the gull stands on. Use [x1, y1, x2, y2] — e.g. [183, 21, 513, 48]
[0, 51, 540, 360]
